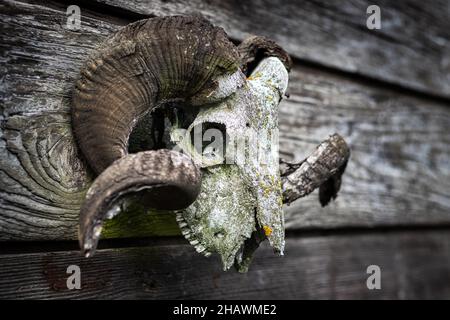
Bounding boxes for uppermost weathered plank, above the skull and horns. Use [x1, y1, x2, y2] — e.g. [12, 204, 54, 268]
[87, 0, 450, 98]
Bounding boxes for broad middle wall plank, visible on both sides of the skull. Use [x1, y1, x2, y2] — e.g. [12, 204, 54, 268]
[0, 1, 450, 240]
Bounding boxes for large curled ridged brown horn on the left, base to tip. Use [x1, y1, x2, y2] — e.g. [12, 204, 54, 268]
[72, 16, 239, 255]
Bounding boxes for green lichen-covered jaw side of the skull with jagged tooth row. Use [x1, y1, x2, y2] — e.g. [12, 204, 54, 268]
[179, 165, 256, 270]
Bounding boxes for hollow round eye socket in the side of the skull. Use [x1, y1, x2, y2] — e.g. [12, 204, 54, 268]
[190, 122, 229, 160]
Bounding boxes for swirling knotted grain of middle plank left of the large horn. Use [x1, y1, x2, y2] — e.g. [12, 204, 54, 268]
[0, 1, 179, 240]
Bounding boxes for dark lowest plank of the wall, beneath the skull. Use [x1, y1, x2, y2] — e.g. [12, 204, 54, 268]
[0, 230, 450, 299]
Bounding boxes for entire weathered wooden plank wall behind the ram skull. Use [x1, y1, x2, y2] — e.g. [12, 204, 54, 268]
[0, 0, 450, 298]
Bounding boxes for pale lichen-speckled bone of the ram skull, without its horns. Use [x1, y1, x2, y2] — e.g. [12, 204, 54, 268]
[171, 57, 288, 270]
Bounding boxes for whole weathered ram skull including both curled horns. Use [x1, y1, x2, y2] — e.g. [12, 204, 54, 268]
[72, 16, 349, 271]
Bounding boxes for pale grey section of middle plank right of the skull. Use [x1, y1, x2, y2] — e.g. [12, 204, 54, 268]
[280, 66, 450, 228]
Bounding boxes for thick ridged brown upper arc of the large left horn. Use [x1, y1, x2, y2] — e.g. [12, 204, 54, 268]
[72, 16, 239, 174]
